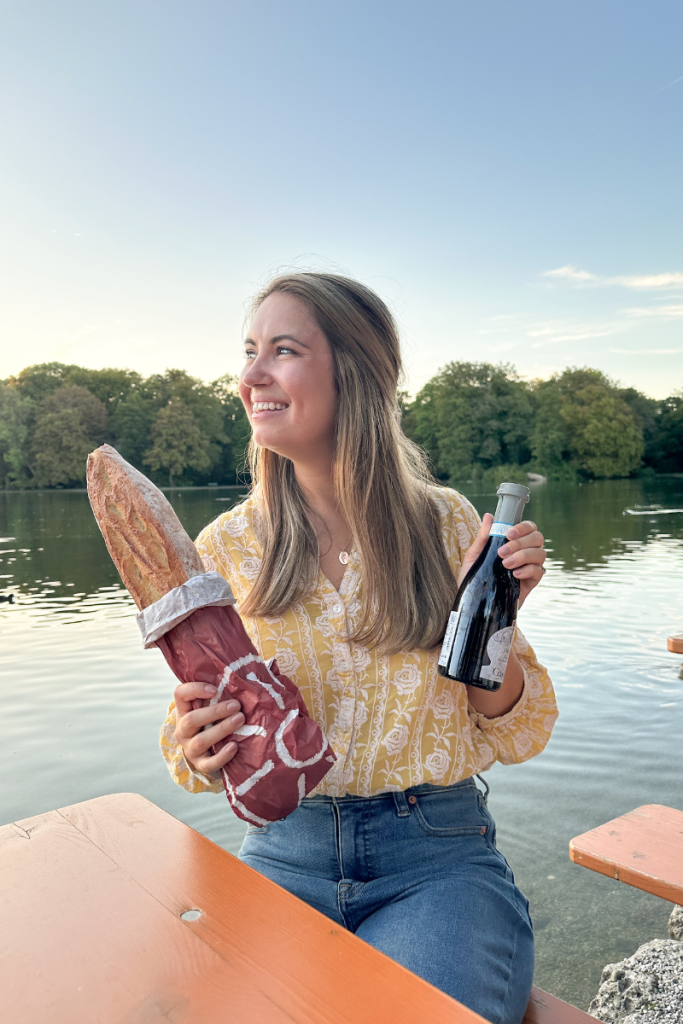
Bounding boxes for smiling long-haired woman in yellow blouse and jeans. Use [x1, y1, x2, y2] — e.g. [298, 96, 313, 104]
[162, 273, 557, 1024]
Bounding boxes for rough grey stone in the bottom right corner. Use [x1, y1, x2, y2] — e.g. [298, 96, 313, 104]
[588, 939, 683, 1024]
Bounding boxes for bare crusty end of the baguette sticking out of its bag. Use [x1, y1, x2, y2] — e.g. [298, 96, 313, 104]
[87, 444, 205, 608]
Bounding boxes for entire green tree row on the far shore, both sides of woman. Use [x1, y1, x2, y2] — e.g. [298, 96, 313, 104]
[0, 362, 683, 489]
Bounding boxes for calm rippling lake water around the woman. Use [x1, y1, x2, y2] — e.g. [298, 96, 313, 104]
[0, 479, 683, 1007]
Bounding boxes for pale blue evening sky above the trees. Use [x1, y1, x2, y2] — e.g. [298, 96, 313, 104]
[0, 0, 683, 398]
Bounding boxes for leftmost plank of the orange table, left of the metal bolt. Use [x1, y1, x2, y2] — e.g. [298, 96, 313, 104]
[0, 811, 252, 1024]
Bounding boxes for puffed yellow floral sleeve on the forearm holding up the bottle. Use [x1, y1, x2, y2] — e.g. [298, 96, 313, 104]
[469, 630, 558, 764]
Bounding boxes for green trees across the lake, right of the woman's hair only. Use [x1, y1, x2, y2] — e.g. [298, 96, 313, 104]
[403, 362, 683, 481]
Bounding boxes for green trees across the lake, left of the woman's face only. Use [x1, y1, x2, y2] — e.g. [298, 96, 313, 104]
[0, 362, 249, 488]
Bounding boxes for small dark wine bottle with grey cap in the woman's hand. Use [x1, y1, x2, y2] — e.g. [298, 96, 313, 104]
[438, 483, 529, 690]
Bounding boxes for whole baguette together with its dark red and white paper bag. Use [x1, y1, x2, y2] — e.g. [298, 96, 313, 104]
[88, 444, 335, 825]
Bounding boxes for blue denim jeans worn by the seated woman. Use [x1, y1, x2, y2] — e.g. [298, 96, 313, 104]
[240, 778, 533, 1024]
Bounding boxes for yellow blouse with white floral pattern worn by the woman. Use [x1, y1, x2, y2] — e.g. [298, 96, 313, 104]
[161, 487, 557, 797]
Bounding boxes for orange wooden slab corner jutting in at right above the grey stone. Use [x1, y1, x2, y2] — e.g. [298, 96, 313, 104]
[569, 804, 683, 905]
